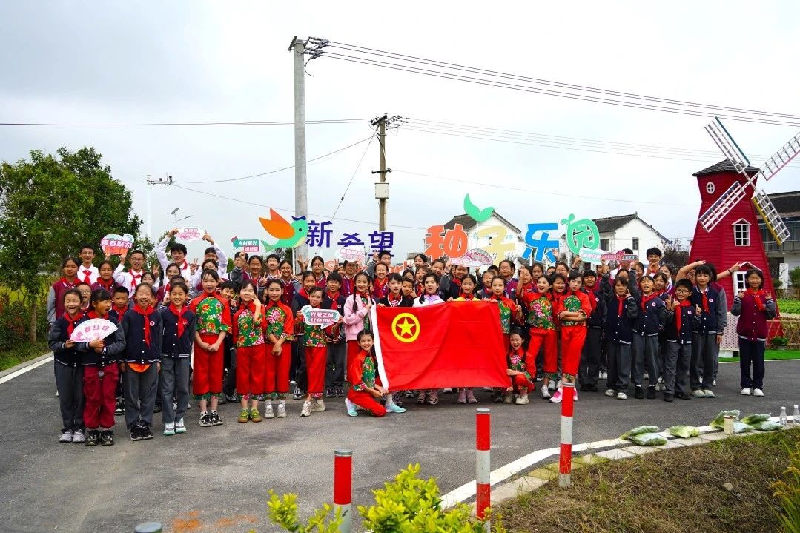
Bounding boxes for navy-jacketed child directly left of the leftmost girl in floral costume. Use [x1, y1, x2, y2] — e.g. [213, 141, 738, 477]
[159, 282, 197, 436]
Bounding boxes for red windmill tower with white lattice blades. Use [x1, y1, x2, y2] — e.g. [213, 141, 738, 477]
[689, 119, 800, 309]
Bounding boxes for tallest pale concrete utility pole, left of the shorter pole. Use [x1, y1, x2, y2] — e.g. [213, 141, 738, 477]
[289, 36, 308, 266]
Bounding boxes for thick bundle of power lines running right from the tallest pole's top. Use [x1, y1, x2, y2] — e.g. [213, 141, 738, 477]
[322, 41, 800, 126]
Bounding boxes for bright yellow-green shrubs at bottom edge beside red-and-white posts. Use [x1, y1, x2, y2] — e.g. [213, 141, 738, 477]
[267, 464, 496, 533]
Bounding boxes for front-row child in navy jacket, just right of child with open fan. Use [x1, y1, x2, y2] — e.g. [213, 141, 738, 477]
[122, 283, 163, 441]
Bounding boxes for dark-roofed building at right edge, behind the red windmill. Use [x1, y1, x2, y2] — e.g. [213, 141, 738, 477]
[758, 191, 800, 287]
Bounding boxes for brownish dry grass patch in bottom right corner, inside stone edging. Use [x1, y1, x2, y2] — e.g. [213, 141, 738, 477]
[500, 429, 800, 533]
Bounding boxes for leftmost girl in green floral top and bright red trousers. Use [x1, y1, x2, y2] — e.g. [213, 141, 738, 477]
[189, 269, 231, 427]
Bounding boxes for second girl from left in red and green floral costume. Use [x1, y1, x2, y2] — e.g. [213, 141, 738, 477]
[233, 281, 267, 424]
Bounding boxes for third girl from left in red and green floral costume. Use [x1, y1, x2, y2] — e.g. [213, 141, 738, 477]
[263, 279, 294, 418]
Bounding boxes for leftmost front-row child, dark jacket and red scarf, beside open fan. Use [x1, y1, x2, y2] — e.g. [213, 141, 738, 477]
[47, 288, 86, 443]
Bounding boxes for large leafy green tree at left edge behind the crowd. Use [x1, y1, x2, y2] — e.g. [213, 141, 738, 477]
[0, 148, 141, 341]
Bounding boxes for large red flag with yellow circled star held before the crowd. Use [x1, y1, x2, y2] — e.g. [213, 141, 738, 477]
[372, 302, 510, 391]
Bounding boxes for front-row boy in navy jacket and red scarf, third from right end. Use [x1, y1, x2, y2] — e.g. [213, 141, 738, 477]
[664, 279, 702, 402]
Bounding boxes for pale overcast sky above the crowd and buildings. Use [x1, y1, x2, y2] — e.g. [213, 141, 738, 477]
[0, 1, 800, 262]
